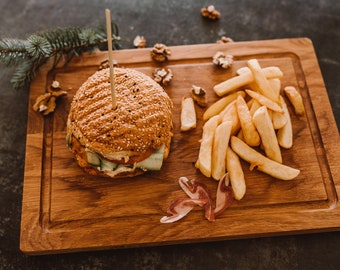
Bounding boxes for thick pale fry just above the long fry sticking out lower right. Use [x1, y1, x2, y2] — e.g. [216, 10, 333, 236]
[253, 106, 282, 163]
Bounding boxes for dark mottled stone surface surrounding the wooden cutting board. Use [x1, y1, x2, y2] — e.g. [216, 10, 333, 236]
[0, 0, 340, 270]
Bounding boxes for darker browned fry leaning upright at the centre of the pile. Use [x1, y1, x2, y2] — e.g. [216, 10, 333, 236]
[236, 96, 261, 146]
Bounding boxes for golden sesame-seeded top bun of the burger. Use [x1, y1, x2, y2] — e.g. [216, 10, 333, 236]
[67, 68, 173, 160]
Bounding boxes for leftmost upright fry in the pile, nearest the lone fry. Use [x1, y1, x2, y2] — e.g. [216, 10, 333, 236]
[195, 115, 220, 177]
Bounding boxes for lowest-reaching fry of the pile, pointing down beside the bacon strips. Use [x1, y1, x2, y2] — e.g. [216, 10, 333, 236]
[226, 147, 246, 200]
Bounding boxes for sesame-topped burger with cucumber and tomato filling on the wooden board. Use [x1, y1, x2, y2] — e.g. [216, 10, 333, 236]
[66, 68, 173, 178]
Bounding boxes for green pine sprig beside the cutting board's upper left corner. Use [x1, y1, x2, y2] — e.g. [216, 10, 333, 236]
[0, 23, 119, 89]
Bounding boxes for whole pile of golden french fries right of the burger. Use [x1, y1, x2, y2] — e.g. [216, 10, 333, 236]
[195, 59, 304, 200]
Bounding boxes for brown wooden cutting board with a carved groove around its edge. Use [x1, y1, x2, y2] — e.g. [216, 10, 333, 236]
[20, 38, 340, 254]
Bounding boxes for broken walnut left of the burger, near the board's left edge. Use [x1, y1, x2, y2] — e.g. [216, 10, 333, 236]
[33, 81, 67, 115]
